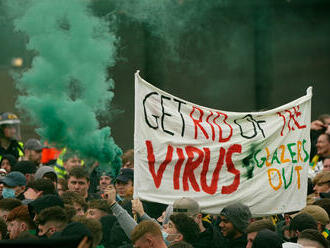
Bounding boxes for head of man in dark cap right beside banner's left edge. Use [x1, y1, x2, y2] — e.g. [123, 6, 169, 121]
[115, 168, 134, 198]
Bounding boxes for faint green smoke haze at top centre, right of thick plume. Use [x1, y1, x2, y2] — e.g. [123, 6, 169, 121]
[113, 0, 227, 59]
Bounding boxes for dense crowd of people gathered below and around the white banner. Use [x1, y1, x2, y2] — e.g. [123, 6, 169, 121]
[0, 113, 330, 248]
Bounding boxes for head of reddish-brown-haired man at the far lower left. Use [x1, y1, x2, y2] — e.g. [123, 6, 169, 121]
[7, 205, 34, 239]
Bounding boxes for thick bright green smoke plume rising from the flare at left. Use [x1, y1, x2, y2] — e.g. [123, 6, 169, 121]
[7, 0, 122, 171]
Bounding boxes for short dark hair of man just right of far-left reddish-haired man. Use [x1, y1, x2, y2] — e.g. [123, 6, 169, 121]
[37, 206, 68, 225]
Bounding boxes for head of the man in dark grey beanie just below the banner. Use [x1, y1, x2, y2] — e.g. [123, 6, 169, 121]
[219, 203, 251, 239]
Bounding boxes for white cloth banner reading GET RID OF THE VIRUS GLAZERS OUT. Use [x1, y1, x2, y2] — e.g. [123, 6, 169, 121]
[134, 72, 312, 215]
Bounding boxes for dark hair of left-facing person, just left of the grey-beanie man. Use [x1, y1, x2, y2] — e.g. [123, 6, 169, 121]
[170, 214, 200, 244]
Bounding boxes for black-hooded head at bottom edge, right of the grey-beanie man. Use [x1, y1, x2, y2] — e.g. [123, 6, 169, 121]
[252, 229, 283, 248]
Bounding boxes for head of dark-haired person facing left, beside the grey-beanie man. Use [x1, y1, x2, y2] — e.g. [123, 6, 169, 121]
[165, 214, 200, 244]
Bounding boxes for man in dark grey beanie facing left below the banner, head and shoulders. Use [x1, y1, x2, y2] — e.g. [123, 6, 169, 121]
[219, 203, 251, 248]
